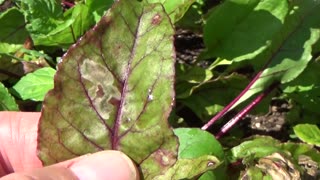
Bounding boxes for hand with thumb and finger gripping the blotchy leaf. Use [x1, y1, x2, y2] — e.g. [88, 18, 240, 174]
[0, 112, 138, 180]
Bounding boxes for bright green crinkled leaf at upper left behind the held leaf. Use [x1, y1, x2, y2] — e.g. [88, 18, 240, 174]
[22, 0, 112, 47]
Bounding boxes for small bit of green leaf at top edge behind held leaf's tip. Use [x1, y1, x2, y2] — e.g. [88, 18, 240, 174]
[147, 0, 196, 23]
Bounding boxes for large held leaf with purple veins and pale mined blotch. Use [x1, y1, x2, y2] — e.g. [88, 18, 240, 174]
[38, 0, 178, 179]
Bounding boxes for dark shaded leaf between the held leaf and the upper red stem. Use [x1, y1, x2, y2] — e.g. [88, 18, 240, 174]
[176, 73, 249, 120]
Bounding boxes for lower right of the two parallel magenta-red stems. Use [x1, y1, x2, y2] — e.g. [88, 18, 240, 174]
[216, 83, 278, 139]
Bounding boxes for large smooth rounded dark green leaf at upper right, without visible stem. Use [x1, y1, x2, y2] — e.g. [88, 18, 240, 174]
[204, 0, 288, 61]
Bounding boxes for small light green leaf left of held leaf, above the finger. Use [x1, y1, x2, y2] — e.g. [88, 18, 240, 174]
[13, 67, 56, 101]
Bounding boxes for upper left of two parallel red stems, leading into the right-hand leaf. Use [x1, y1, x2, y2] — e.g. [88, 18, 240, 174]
[201, 71, 263, 130]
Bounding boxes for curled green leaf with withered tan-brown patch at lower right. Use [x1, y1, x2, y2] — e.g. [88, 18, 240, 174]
[228, 136, 320, 179]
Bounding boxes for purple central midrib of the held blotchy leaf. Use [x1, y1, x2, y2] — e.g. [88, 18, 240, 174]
[111, 9, 144, 150]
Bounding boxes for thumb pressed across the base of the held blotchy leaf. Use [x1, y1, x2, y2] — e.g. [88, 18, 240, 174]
[0, 151, 138, 180]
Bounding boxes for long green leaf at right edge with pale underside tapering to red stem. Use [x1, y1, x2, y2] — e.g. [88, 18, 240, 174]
[234, 0, 320, 107]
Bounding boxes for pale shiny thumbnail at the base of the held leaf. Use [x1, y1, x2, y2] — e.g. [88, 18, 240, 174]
[69, 151, 138, 180]
